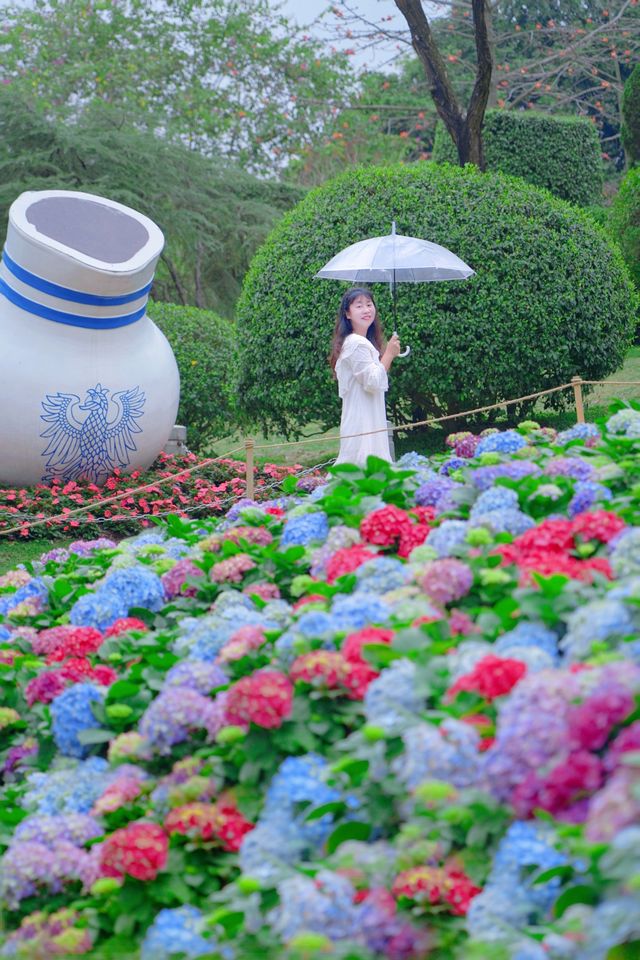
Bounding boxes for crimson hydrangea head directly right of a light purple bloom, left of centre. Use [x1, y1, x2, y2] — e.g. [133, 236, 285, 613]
[226, 670, 293, 730]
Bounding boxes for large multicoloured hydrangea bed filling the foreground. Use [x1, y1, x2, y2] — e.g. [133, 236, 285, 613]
[0, 407, 640, 960]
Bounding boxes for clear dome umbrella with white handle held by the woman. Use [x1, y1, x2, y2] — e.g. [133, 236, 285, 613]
[315, 220, 474, 357]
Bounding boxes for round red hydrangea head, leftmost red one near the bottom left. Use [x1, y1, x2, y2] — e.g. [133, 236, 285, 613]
[100, 821, 169, 880]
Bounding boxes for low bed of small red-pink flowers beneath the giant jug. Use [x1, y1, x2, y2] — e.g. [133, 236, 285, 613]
[0, 453, 314, 539]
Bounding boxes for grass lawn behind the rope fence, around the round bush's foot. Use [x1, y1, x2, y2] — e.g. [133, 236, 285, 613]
[210, 346, 640, 467]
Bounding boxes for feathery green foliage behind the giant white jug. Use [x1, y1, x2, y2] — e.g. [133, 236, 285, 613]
[0, 85, 304, 317]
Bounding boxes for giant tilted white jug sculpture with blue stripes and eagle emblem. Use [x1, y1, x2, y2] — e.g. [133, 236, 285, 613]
[0, 190, 180, 486]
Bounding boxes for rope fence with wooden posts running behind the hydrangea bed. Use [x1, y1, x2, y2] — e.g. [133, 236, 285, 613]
[0, 377, 640, 537]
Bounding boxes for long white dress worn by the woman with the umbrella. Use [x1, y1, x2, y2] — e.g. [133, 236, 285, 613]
[336, 333, 391, 467]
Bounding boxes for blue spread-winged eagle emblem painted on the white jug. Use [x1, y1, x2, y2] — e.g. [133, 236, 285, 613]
[40, 383, 145, 484]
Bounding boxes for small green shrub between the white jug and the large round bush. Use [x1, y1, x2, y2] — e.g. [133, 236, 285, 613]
[148, 301, 235, 451]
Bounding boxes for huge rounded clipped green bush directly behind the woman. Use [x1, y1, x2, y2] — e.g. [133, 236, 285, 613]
[237, 163, 636, 435]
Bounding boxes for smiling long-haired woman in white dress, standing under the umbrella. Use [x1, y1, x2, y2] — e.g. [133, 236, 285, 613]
[329, 287, 400, 467]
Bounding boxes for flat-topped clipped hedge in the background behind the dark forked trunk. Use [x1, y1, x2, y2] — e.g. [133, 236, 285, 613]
[432, 110, 603, 206]
